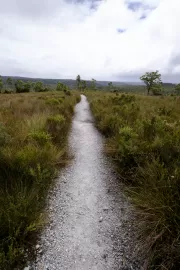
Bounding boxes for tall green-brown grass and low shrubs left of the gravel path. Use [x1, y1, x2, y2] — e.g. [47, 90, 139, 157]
[0, 92, 79, 269]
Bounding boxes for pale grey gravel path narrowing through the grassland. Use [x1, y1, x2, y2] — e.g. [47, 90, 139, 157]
[34, 95, 140, 270]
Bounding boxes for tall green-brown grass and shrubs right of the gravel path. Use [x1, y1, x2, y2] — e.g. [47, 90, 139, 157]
[87, 92, 180, 270]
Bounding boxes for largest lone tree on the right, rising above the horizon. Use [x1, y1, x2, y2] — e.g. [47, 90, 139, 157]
[140, 70, 162, 95]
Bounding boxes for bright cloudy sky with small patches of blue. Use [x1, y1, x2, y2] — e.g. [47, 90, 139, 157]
[0, 0, 180, 82]
